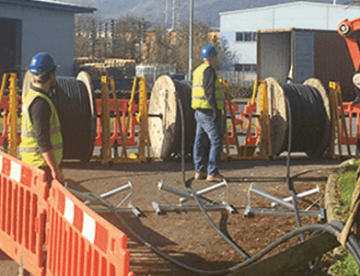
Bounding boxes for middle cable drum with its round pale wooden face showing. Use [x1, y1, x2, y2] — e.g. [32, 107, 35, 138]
[148, 75, 196, 160]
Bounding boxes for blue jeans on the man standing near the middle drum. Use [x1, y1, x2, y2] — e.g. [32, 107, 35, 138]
[193, 109, 223, 175]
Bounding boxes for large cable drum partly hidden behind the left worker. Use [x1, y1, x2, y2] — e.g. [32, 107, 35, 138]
[22, 71, 97, 162]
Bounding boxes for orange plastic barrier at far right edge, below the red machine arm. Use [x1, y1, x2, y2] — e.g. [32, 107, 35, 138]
[338, 102, 360, 145]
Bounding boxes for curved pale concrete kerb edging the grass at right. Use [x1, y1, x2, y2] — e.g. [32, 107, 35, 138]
[324, 158, 355, 276]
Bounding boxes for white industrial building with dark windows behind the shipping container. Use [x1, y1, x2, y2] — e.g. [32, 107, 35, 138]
[220, 1, 360, 72]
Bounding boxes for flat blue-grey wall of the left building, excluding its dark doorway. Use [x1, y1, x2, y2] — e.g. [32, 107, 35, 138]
[0, 4, 74, 76]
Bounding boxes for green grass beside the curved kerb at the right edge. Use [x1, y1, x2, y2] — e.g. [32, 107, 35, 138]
[333, 161, 360, 276]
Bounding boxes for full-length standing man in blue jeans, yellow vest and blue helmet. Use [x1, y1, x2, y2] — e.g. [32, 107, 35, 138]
[191, 45, 224, 182]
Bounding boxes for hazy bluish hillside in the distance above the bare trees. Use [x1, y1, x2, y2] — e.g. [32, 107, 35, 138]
[88, 0, 349, 27]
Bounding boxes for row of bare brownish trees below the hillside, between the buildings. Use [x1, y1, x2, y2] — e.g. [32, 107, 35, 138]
[75, 15, 235, 73]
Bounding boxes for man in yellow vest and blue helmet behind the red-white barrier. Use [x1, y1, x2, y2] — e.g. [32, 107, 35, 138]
[20, 53, 64, 183]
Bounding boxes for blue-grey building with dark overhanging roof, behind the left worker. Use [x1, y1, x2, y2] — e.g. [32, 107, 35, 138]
[0, 0, 95, 76]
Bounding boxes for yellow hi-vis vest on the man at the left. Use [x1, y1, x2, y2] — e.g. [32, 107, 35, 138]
[20, 89, 63, 167]
